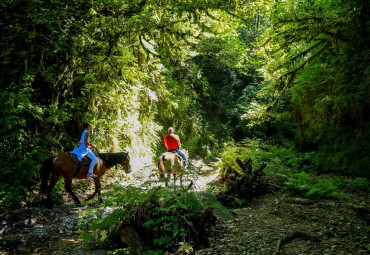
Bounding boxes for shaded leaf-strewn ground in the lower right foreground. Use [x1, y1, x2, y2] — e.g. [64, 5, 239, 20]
[197, 193, 370, 255]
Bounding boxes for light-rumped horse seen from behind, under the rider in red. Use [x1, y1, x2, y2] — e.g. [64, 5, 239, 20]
[158, 150, 188, 187]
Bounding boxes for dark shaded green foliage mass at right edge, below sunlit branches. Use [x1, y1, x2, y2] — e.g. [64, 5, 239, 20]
[292, 46, 370, 177]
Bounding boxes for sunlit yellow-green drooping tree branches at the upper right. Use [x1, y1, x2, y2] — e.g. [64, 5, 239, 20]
[244, 0, 366, 124]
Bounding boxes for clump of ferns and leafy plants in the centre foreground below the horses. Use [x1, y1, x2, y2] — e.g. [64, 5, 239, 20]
[79, 180, 232, 254]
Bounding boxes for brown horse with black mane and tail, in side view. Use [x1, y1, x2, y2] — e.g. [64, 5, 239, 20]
[40, 152, 131, 206]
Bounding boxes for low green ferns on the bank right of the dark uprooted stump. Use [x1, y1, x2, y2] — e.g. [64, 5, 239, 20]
[217, 139, 370, 199]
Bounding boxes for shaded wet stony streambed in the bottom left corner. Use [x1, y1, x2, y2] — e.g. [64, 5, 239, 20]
[0, 203, 84, 254]
